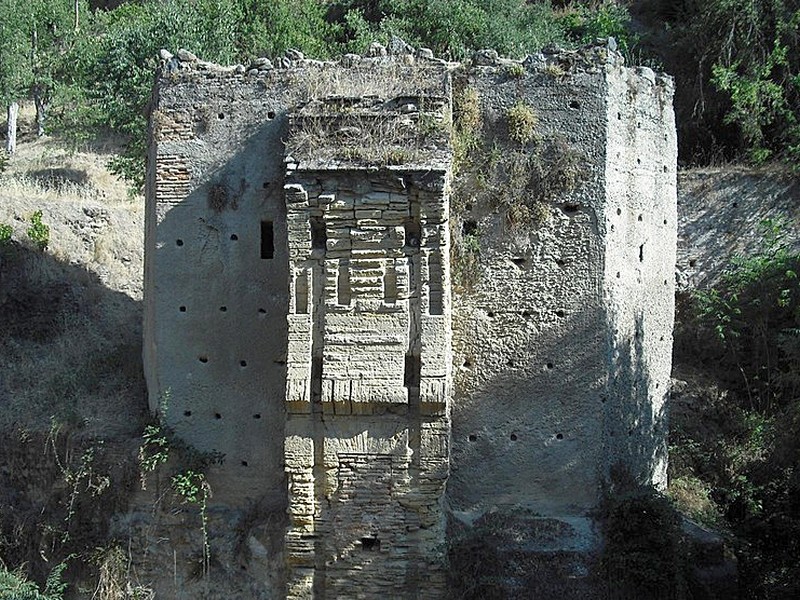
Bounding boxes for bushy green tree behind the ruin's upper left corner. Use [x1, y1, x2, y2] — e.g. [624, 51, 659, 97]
[56, 0, 242, 186]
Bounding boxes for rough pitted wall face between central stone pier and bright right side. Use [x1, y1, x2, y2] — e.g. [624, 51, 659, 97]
[448, 69, 608, 515]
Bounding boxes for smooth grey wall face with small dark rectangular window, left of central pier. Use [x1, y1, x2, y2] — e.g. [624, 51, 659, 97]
[145, 80, 288, 506]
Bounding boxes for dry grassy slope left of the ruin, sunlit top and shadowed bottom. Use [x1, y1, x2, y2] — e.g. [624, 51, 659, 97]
[0, 106, 147, 599]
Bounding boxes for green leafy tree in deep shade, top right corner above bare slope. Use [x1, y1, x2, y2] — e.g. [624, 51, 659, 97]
[652, 0, 800, 166]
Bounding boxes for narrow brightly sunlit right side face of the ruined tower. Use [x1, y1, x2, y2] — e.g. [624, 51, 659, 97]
[602, 67, 678, 488]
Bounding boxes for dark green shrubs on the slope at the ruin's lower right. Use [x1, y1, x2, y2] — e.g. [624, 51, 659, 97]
[670, 221, 800, 598]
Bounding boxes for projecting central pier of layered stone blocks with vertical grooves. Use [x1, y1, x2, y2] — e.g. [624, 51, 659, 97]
[285, 170, 450, 598]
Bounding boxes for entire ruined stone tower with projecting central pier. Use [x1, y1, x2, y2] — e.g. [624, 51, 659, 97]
[145, 39, 676, 597]
